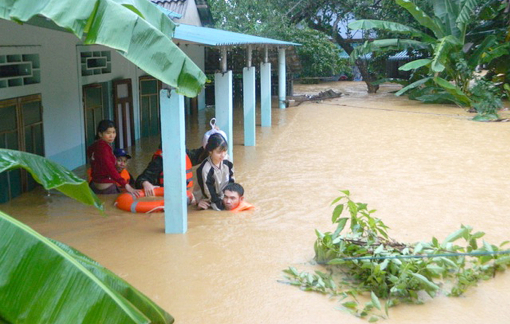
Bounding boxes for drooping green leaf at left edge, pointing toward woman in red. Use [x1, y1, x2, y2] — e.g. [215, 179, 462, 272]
[0, 149, 103, 210]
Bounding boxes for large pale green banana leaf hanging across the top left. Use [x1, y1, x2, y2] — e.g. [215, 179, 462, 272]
[0, 0, 206, 97]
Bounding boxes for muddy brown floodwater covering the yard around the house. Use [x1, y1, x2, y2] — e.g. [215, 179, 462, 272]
[0, 82, 510, 324]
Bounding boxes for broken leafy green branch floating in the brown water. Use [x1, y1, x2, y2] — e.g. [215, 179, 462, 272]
[284, 190, 510, 322]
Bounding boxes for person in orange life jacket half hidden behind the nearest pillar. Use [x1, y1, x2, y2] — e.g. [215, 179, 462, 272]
[135, 145, 204, 204]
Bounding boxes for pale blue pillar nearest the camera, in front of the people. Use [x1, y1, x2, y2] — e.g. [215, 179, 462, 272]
[159, 89, 188, 233]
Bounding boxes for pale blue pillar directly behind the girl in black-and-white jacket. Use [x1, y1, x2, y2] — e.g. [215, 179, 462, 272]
[214, 71, 234, 161]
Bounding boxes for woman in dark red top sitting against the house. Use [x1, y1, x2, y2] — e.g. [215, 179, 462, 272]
[87, 120, 139, 197]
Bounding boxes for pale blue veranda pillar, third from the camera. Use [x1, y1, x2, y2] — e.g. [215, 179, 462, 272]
[243, 66, 256, 146]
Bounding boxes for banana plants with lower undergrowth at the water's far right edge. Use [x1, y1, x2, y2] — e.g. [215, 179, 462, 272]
[349, 0, 510, 120]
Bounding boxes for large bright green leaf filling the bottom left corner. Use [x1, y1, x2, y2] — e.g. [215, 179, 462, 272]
[0, 212, 173, 324]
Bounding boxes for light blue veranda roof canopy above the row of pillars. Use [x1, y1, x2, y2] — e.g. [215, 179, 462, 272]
[174, 24, 301, 46]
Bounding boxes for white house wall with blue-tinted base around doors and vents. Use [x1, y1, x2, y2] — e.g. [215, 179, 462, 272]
[0, 19, 139, 169]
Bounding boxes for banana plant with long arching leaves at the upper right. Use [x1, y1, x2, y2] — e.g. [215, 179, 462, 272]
[349, 0, 510, 117]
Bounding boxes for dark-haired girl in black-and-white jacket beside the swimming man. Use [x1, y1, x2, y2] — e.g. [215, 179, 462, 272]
[197, 133, 235, 210]
